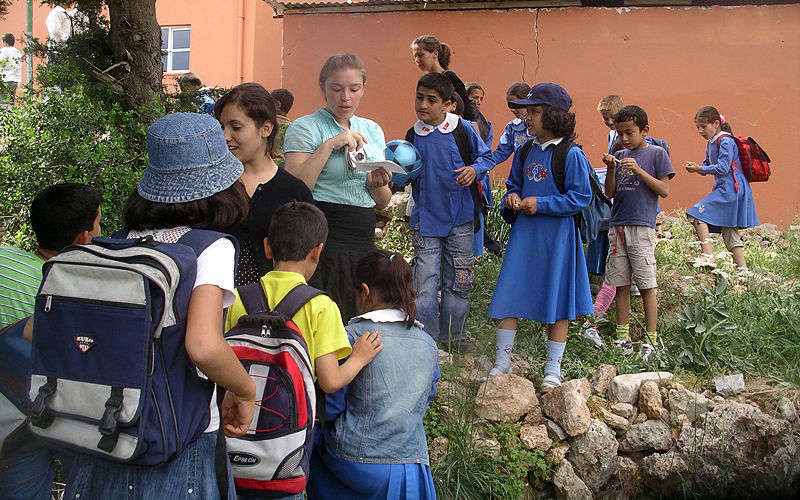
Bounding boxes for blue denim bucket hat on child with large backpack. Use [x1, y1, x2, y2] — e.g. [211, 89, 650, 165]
[136, 113, 244, 203]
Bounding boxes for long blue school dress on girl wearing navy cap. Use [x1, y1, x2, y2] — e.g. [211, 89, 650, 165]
[488, 139, 594, 324]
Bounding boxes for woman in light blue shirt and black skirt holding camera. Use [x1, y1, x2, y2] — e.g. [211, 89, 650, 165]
[283, 54, 391, 323]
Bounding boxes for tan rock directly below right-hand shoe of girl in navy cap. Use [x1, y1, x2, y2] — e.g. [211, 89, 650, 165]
[542, 378, 591, 436]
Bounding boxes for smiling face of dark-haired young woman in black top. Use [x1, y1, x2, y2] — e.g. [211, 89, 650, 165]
[219, 103, 273, 163]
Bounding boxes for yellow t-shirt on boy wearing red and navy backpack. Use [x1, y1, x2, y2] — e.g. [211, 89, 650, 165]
[225, 271, 352, 376]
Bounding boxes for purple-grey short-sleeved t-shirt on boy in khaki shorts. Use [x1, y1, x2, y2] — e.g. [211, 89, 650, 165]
[609, 144, 675, 228]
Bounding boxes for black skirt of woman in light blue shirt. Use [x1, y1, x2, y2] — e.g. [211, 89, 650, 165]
[309, 201, 375, 325]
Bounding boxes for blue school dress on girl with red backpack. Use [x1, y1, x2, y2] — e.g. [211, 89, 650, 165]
[686, 132, 759, 229]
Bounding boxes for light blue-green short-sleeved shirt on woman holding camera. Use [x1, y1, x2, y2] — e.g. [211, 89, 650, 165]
[283, 108, 386, 208]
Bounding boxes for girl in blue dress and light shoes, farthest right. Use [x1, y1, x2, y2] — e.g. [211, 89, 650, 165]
[686, 106, 759, 271]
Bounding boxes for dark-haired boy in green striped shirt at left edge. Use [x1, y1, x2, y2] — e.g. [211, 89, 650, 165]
[0, 183, 101, 498]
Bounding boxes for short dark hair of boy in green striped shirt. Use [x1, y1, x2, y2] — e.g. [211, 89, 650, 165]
[31, 182, 102, 252]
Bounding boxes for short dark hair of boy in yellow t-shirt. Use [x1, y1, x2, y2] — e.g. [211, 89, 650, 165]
[268, 201, 328, 262]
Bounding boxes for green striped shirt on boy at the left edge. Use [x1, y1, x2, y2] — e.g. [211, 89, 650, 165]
[0, 246, 44, 326]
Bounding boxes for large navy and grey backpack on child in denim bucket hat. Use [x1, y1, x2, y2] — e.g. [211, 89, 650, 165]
[29, 229, 236, 465]
